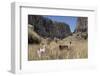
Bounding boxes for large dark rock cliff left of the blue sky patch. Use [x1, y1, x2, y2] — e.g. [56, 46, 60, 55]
[28, 15, 71, 39]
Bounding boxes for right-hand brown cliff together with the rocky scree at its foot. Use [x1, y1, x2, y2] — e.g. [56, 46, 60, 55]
[74, 17, 88, 40]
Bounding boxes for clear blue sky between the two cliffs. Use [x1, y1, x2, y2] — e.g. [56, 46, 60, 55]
[44, 16, 77, 32]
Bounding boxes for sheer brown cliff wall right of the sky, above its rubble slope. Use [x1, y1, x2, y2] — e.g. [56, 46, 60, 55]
[74, 17, 88, 33]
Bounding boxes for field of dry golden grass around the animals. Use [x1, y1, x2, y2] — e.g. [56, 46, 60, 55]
[28, 36, 88, 61]
